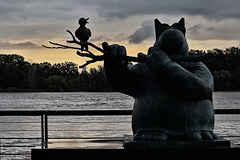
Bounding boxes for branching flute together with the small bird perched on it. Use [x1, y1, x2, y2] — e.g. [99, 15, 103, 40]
[42, 18, 206, 68]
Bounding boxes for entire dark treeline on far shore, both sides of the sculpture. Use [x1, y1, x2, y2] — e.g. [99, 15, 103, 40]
[0, 47, 240, 92]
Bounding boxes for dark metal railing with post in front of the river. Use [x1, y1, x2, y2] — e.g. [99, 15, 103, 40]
[0, 109, 240, 157]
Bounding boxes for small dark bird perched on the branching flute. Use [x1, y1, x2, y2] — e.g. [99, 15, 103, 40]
[75, 18, 91, 51]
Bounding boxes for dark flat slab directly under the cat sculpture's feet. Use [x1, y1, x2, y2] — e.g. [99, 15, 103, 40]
[123, 136, 231, 150]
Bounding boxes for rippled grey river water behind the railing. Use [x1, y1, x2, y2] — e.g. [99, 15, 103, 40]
[0, 92, 240, 159]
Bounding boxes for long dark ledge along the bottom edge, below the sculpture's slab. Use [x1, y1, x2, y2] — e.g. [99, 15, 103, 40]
[32, 148, 240, 160]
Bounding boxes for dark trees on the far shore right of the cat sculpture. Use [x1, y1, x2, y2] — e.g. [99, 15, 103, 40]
[190, 47, 240, 91]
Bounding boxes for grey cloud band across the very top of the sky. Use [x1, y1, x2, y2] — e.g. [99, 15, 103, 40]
[0, 0, 240, 20]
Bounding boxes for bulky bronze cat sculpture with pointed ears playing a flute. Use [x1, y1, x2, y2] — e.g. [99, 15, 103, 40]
[103, 18, 217, 141]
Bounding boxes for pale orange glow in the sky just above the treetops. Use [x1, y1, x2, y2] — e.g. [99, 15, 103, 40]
[1, 40, 238, 67]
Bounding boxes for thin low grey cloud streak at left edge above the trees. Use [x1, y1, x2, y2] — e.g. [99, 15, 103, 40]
[0, 42, 40, 50]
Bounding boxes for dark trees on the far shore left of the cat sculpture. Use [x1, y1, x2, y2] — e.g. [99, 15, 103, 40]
[0, 54, 112, 91]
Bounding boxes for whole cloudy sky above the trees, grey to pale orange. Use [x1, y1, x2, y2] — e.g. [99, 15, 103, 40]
[0, 0, 240, 67]
